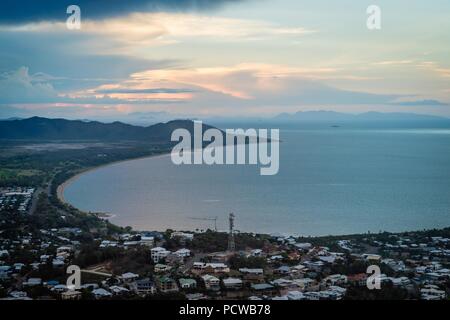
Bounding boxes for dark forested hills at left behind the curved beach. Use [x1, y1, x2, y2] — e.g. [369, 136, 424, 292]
[0, 117, 214, 143]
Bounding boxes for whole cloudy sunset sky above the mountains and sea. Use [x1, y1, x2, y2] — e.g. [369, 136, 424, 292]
[0, 0, 450, 121]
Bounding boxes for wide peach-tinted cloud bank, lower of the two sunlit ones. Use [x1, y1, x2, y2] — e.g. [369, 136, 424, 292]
[76, 64, 398, 114]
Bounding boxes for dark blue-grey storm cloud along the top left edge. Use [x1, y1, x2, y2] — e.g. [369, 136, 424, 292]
[0, 0, 242, 24]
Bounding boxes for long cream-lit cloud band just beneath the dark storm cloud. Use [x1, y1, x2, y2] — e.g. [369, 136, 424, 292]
[0, 12, 316, 54]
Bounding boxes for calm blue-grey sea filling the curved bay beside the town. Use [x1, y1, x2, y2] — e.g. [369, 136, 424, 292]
[64, 127, 450, 235]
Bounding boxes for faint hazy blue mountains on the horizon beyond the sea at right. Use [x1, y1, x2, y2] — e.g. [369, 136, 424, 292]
[273, 111, 450, 122]
